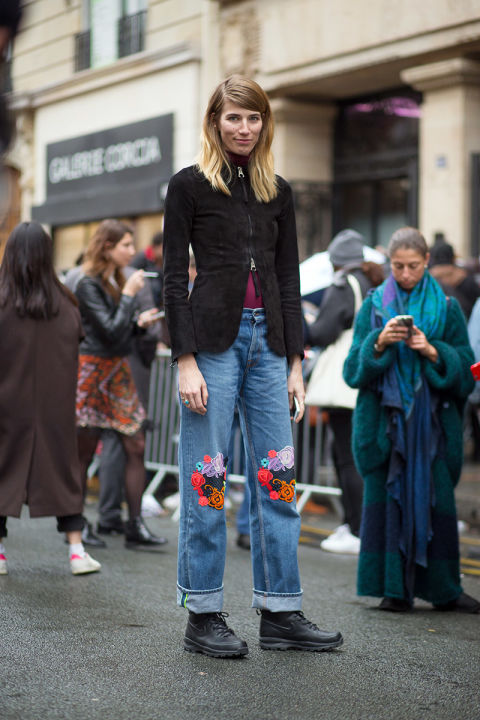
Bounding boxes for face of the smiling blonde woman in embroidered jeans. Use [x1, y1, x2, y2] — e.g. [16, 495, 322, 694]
[217, 100, 263, 155]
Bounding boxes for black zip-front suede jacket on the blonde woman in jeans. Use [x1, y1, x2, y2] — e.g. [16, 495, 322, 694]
[163, 167, 303, 360]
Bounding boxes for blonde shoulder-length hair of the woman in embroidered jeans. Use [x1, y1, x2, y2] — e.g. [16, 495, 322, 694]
[196, 75, 278, 202]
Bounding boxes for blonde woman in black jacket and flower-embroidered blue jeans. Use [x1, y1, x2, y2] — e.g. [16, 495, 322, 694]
[164, 76, 342, 657]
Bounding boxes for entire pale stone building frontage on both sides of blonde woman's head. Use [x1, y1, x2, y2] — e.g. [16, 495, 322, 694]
[4, 0, 480, 267]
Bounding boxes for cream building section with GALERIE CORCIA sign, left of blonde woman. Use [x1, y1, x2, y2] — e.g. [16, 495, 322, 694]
[7, 0, 221, 269]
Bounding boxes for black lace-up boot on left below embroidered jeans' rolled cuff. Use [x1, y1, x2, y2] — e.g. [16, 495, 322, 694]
[183, 612, 248, 657]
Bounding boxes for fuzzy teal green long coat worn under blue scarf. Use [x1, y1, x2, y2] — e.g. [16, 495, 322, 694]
[343, 297, 474, 605]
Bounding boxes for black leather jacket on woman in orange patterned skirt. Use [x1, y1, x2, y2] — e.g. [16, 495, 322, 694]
[75, 275, 137, 357]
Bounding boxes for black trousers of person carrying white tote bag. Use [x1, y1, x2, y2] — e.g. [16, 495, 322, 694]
[328, 408, 363, 536]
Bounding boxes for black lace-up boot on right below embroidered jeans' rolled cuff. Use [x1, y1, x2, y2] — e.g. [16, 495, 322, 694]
[260, 610, 343, 652]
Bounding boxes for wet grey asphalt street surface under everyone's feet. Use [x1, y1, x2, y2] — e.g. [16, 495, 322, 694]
[0, 506, 480, 720]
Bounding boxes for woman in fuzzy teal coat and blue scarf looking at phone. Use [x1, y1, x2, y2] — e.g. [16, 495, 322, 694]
[343, 228, 480, 613]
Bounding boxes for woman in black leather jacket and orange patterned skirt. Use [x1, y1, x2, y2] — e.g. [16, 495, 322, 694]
[75, 219, 167, 548]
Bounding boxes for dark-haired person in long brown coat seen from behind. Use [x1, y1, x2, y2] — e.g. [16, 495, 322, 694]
[0, 223, 100, 575]
